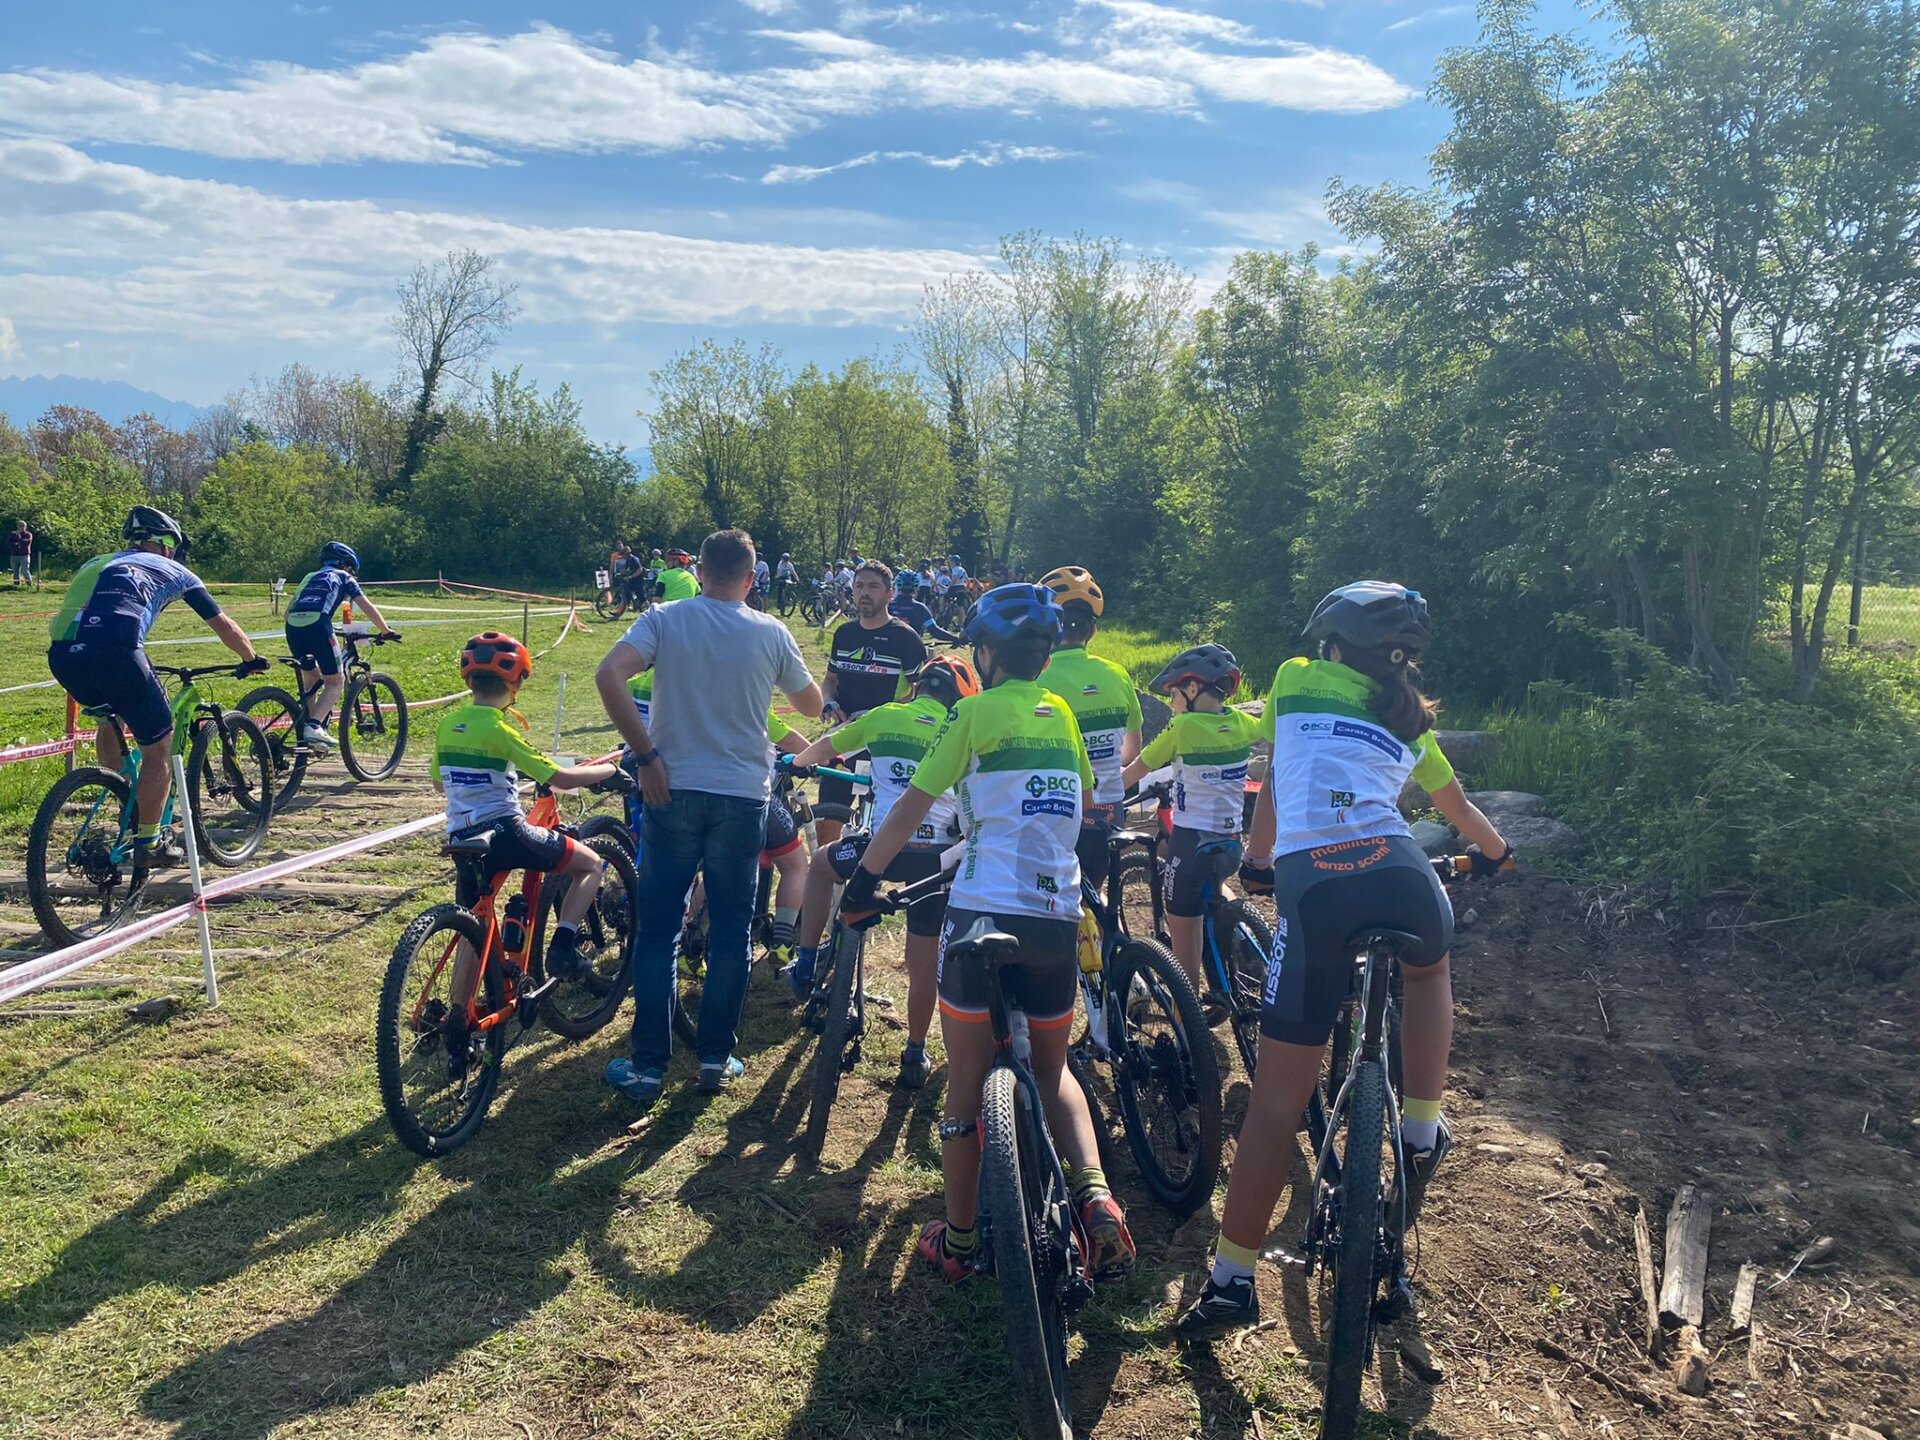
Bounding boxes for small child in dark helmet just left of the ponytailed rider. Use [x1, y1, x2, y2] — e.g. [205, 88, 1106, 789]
[1121, 643, 1261, 993]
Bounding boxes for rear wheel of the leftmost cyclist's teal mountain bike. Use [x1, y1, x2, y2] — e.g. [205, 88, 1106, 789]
[27, 766, 144, 945]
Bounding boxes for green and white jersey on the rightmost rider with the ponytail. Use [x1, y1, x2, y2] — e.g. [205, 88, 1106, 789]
[1267, 659, 1453, 860]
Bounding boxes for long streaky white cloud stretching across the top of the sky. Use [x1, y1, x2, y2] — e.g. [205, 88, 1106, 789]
[0, 21, 1413, 165]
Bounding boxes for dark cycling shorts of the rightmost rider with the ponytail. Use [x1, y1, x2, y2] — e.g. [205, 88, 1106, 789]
[1260, 835, 1453, 1044]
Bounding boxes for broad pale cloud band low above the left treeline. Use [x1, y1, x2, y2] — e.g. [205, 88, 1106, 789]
[0, 140, 985, 341]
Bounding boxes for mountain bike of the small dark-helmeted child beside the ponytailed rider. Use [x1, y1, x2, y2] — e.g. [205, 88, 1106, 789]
[1116, 783, 1273, 1077]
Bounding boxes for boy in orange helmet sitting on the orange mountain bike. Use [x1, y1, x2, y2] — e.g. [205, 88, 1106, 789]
[434, 630, 616, 979]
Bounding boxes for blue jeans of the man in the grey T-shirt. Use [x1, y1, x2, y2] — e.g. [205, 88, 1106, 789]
[634, 789, 766, 1069]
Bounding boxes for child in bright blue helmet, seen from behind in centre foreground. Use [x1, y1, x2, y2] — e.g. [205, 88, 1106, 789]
[841, 586, 1133, 1281]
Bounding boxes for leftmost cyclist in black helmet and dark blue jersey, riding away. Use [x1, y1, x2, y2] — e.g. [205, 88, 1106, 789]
[46, 505, 267, 883]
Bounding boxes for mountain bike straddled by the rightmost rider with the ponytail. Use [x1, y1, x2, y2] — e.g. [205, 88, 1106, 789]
[1302, 856, 1473, 1440]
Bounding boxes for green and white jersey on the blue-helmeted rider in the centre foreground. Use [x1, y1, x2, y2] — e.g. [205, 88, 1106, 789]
[912, 680, 1092, 920]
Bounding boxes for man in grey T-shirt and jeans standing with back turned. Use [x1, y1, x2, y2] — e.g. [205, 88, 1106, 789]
[595, 530, 822, 1106]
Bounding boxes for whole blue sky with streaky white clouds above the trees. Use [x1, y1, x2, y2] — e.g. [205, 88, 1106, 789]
[0, 0, 1576, 444]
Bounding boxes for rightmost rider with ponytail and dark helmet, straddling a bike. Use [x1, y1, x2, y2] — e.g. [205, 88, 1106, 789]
[1177, 580, 1513, 1340]
